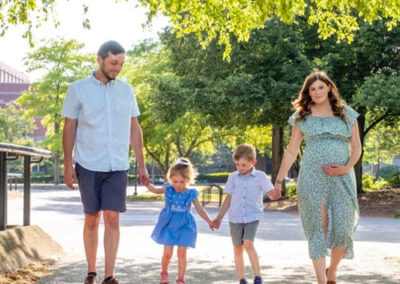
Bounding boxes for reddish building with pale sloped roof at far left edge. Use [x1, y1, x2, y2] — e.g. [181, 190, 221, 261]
[0, 61, 46, 141]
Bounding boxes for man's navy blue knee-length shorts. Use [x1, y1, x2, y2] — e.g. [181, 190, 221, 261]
[75, 163, 128, 214]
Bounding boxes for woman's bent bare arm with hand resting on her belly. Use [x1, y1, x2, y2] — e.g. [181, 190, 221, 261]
[322, 121, 361, 176]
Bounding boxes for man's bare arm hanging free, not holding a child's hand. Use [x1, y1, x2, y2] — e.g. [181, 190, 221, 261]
[62, 118, 78, 189]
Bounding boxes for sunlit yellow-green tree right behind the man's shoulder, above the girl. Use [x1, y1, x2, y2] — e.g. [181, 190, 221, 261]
[124, 42, 242, 177]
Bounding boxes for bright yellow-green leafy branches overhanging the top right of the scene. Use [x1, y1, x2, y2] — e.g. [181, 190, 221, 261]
[141, 0, 400, 59]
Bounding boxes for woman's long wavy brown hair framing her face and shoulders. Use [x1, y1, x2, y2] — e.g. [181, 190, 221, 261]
[293, 71, 347, 122]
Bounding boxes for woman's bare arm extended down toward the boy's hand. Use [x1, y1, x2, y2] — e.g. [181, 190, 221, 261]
[275, 127, 303, 190]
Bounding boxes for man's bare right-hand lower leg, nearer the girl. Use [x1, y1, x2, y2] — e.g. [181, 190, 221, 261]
[103, 210, 119, 278]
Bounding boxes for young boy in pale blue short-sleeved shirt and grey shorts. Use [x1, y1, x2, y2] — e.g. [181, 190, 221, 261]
[213, 144, 280, 284]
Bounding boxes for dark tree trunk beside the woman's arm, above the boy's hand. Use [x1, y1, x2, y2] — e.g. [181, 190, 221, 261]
[271, 127, 285, 195]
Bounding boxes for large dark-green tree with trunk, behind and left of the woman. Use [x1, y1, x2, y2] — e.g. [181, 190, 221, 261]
[161, 20, 311, 189]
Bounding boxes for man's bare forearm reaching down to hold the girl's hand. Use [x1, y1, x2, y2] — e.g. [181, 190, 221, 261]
[130, 117, 149, 185]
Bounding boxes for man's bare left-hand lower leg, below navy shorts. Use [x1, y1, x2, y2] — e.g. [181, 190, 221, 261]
[83, 212, 101, 272]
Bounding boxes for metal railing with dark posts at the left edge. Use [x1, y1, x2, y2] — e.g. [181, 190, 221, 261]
[0, 143, 51, 231]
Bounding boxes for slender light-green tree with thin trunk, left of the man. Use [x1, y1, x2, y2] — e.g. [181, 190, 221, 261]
[17, 39, 94, 184]
